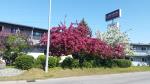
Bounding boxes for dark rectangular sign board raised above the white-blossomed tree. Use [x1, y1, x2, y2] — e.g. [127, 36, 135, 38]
[105, 9, 121, 21]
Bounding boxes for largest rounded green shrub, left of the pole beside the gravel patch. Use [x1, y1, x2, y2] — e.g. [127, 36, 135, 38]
[15, 55, 34, 70]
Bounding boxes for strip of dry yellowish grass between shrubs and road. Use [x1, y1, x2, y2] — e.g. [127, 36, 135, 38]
[0, 67, 150, 81]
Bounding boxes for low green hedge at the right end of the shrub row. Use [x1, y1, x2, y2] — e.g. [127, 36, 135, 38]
[114, 59, 131, 68]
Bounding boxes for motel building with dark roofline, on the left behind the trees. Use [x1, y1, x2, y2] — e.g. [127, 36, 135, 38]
[0, 21, 47, 58]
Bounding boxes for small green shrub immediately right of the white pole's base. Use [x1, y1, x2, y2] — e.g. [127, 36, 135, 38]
[48, 57, 59, 68]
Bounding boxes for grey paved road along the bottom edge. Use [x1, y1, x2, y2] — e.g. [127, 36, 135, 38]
[0, 72, 150, 84]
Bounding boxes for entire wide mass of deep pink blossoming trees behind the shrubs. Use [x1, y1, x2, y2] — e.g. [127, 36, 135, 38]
[41, 23, 124, 59]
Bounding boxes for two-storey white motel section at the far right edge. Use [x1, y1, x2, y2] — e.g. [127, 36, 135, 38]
[127, 43, 150, 66]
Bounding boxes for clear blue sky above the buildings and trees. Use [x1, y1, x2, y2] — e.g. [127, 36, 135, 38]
[0, 0, 150, 43]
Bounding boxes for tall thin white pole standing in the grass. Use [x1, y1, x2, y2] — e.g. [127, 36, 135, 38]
[45, 0, 51, 73]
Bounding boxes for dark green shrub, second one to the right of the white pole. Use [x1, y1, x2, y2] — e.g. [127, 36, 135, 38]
[61, 57, 73, 69]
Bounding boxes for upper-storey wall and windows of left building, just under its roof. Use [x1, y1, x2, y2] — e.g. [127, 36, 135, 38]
[0, 24, 46, 45]
